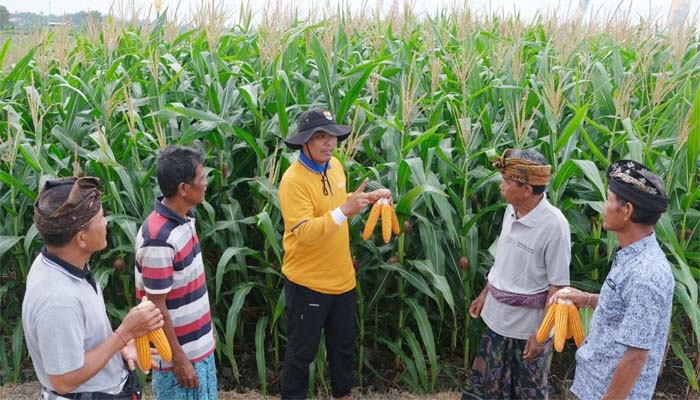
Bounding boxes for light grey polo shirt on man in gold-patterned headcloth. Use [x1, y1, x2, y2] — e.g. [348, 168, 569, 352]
[481, 196, 571, 340]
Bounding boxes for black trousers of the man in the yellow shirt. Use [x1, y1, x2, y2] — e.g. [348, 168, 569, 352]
[282, 280, 357, 400]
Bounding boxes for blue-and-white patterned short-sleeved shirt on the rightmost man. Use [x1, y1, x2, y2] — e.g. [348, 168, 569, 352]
[571, 233, 675, 400]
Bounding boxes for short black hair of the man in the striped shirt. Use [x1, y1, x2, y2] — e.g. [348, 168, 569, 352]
[156, 146, 204, 198]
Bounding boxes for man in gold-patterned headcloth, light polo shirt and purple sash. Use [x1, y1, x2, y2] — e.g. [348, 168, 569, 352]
[462, 150, 571, 400]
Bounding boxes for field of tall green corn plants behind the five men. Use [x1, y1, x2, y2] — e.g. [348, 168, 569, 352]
[0, 3, 700, 394]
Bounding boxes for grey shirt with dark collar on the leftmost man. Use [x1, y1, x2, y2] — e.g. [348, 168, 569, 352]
[22, 251, 128, 394]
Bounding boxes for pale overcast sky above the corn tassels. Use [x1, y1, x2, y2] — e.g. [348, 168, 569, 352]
[5, 0, 700, 23]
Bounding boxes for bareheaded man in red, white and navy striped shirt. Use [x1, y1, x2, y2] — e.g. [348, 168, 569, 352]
[135, 146, 217, 400]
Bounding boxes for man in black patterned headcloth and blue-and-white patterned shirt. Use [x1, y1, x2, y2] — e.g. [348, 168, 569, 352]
[551, 160, 675, 400]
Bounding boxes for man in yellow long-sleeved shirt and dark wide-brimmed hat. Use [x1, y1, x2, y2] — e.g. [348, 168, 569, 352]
[279, 109, 391, 400]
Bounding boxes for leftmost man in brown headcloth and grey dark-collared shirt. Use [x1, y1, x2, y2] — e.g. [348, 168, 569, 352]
[22, 177, 163, 400]
